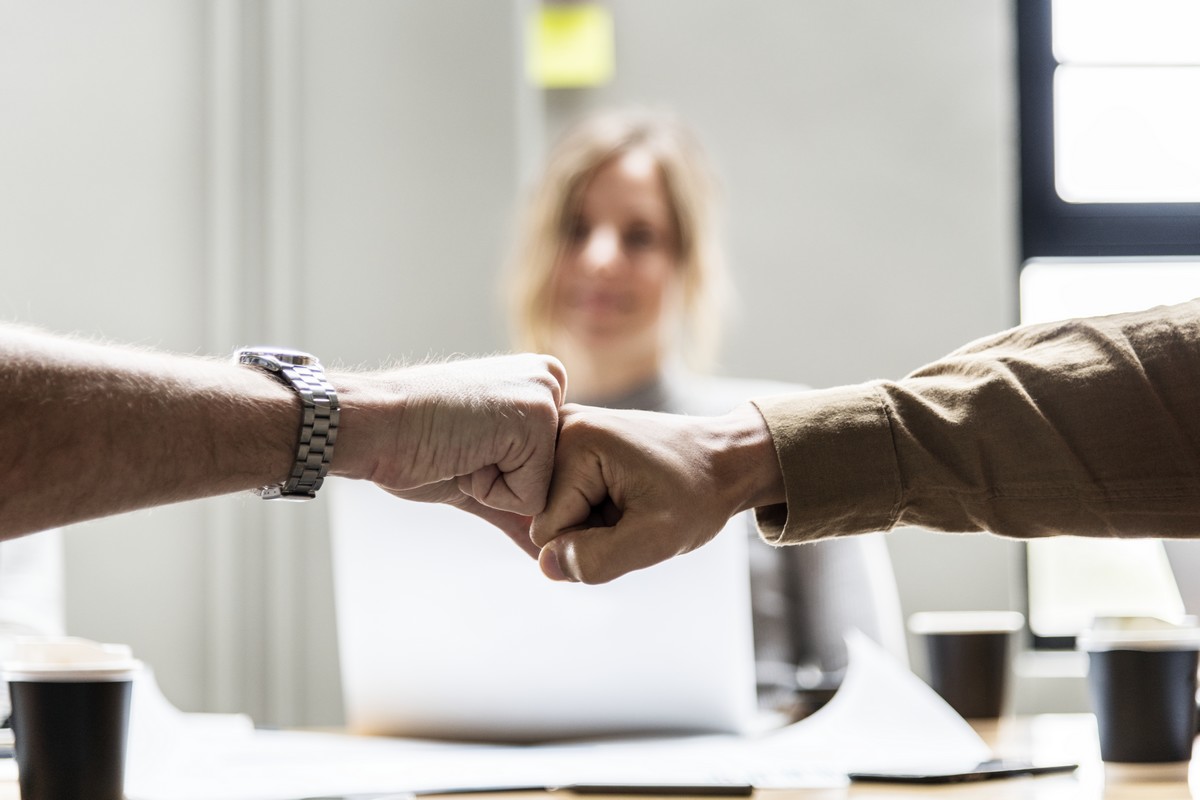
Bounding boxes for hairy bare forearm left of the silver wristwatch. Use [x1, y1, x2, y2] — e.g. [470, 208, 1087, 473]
[0, 325, 299, 537]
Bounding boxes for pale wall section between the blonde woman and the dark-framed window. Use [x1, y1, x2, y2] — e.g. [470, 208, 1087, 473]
[546, 0, 1019, 690]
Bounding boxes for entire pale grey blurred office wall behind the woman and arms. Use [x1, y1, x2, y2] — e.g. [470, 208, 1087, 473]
[0, 0, 1032, 724]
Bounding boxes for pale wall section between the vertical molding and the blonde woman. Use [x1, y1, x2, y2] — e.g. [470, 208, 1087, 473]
[296, 0, 533, 721]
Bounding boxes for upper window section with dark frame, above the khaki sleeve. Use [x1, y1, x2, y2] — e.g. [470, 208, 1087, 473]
[1018, 0, 1200, 261]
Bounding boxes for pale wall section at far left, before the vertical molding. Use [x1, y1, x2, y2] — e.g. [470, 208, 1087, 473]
[0, 1, 205, 706]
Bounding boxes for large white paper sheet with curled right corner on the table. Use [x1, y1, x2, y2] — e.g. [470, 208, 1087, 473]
[126, 633, 990, 800]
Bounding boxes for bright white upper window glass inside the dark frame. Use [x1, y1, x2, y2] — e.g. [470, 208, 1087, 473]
[1052, 0, 1200, 203]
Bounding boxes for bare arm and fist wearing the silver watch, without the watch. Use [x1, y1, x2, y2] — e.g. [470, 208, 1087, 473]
[0, 325, 566, 549]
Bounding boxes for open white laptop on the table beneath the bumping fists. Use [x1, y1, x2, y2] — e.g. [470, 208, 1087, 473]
[323, 480, 756, 741]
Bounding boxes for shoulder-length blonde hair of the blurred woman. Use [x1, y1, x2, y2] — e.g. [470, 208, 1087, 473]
[506, 109, 730, 369]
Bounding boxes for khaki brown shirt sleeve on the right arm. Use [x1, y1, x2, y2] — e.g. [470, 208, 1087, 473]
[755, 301, 1200, 543]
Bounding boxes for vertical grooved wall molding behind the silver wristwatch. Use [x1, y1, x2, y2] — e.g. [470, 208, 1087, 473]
[205, 0, 312, 724]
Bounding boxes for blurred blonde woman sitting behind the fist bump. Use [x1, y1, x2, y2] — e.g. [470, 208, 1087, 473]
[506, 109, 907, 716]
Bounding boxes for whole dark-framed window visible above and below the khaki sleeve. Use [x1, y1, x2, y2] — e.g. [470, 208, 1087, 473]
[1016, 0, 1200, 646]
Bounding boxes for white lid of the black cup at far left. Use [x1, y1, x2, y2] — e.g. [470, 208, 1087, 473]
[0, 636, 142, 682]
